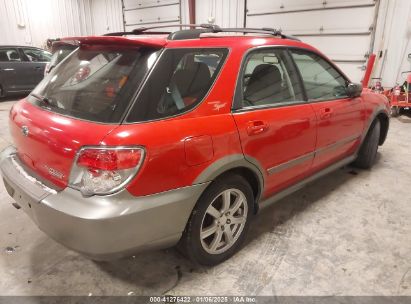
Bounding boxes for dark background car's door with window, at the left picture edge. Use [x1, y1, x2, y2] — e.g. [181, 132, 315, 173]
[0, 47, 27, 92]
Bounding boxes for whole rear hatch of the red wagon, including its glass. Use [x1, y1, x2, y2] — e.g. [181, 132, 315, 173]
[10, 37, 160, 188]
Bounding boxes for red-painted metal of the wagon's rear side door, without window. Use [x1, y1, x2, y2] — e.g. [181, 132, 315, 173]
[234, 104, 316, 197]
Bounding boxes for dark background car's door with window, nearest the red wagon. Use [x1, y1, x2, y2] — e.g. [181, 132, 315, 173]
[20, 47, 51, 89]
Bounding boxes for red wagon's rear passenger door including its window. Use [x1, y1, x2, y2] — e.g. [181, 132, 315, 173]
[233, 47, 316, 197]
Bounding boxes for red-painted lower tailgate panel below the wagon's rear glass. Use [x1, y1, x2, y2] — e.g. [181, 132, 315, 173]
[10, 99, 116, 187]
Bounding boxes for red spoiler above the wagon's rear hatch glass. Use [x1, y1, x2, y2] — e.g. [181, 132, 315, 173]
[58, 36, 167, 48]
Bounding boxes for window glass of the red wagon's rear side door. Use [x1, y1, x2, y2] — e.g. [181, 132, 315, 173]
[242, 49, 303, 107]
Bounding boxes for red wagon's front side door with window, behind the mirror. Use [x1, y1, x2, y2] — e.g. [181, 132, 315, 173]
[290, 49, 365, 170]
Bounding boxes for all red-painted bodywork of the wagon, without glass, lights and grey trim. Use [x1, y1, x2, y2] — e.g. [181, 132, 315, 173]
[10, 36, 387, 197]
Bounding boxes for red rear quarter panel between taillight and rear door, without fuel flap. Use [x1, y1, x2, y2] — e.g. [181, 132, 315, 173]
[104, 114, 241, 196]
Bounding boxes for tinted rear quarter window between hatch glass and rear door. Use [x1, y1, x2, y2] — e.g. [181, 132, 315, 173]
[127, 49, 227, 122]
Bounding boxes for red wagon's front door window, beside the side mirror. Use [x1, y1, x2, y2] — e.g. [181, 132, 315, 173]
[291, 50, 347, 101]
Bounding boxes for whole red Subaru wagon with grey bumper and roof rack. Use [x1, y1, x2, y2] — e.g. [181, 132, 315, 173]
[0, 26, 389, 265]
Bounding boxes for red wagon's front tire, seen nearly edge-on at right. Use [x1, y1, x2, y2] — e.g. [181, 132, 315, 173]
[354, 119, 381, 169]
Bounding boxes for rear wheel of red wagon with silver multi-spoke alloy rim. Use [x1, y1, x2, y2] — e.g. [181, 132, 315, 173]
[178, 175, 254, 266]
